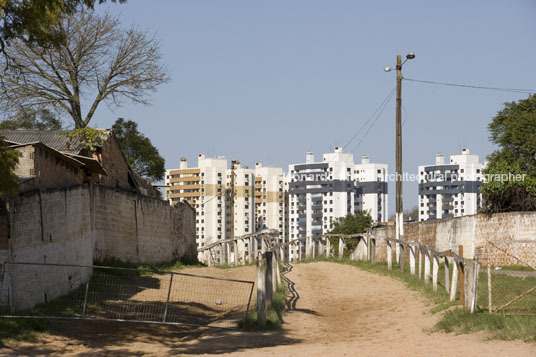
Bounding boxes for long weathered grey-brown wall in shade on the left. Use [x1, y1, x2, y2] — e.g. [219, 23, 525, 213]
[0, 185, 196, 309]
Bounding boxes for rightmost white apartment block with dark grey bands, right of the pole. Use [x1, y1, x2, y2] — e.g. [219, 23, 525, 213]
[419, 148, 483, 221]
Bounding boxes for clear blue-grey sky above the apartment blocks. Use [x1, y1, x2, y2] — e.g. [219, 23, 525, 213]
[91, 0, 536, 212]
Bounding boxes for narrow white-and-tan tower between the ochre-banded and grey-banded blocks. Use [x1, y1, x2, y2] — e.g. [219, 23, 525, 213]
[255, 163, 288, 242]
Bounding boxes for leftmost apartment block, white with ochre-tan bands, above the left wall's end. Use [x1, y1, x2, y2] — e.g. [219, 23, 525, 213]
[165, 154, 255, 248]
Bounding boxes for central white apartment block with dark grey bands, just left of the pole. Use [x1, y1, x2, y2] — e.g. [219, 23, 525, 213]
[289, 147, 387, 240]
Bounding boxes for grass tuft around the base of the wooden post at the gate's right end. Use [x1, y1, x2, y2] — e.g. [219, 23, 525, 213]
[239, 285, 287, 331]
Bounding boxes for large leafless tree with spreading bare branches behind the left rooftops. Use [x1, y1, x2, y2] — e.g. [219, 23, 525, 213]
[0, 8, 169, 128]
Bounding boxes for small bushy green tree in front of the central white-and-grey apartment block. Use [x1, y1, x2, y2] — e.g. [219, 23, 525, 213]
[329, 211, 372, 255]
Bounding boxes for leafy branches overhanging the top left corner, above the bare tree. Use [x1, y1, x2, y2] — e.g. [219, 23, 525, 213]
[0, 0, 126, 52]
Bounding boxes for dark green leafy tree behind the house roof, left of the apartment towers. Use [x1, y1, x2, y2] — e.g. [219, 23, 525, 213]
[112, 118, 166, 181]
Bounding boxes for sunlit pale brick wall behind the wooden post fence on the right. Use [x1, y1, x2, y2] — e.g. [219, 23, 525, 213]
[373, 212, 536, 265]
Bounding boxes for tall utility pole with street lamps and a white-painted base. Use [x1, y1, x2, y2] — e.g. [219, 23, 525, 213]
[384, 52, 415, 270]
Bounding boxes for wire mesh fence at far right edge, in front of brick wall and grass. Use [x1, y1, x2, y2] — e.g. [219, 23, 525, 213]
[486, 240, 536, 315]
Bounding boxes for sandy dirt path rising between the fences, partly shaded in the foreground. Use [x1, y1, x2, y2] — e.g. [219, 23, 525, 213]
[0, 262, 536, 356]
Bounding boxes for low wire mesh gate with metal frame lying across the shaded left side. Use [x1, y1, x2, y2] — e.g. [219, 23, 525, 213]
[0, 263, 254, 328]
